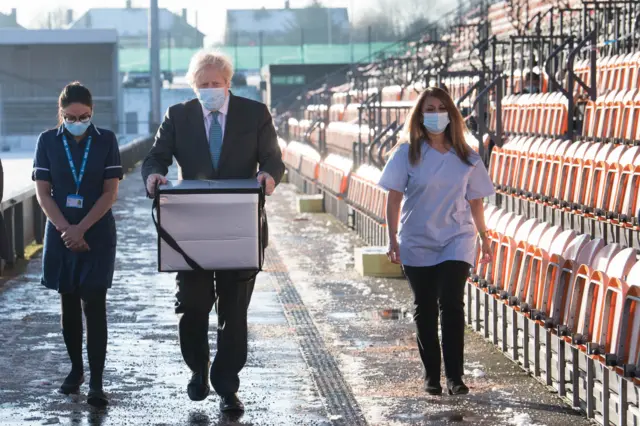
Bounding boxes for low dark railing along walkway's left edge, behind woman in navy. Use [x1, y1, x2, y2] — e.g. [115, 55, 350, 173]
[0, 135, 154, 276]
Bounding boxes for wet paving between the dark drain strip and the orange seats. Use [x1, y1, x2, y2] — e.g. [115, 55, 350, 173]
[268, 187, 592, 426]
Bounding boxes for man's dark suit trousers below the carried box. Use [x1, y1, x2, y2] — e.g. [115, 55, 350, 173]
[176, 271, 255, 395]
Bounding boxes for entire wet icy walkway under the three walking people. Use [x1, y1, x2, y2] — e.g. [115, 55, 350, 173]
[0, 168, 591, 426]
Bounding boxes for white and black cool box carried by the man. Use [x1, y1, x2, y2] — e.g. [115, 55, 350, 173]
[154, 179, 267, 272]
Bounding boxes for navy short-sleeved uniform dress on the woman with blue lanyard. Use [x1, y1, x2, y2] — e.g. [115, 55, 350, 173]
[32, 124, 122, 295]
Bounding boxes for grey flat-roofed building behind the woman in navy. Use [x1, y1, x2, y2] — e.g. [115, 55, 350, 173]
[0, 29, 122, 150]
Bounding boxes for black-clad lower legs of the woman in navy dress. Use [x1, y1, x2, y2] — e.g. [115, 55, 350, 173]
[60, 291, 107, 387]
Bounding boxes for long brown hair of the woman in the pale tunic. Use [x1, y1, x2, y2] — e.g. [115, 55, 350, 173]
[394, 87, 471, 165]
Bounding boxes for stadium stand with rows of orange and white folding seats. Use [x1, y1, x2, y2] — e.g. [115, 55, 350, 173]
[276, 0, 640, 426]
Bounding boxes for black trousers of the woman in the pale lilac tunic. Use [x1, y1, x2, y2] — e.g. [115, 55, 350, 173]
[403, 261, 470, 381]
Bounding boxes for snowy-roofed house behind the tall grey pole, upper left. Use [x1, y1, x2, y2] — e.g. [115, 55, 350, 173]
[69, 1, 205, 49]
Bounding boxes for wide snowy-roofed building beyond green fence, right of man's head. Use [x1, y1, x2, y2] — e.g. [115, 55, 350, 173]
[224, 6, 350, 46]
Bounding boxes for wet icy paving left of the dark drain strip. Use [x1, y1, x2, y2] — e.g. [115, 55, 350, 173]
[0, 170, 327, 425]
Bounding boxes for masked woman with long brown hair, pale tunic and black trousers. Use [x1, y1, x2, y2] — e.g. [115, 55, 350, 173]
[379, 87, 494, 395]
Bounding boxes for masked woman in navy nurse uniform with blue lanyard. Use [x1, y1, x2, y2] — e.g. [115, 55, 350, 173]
[33, 82, 122, 406]
